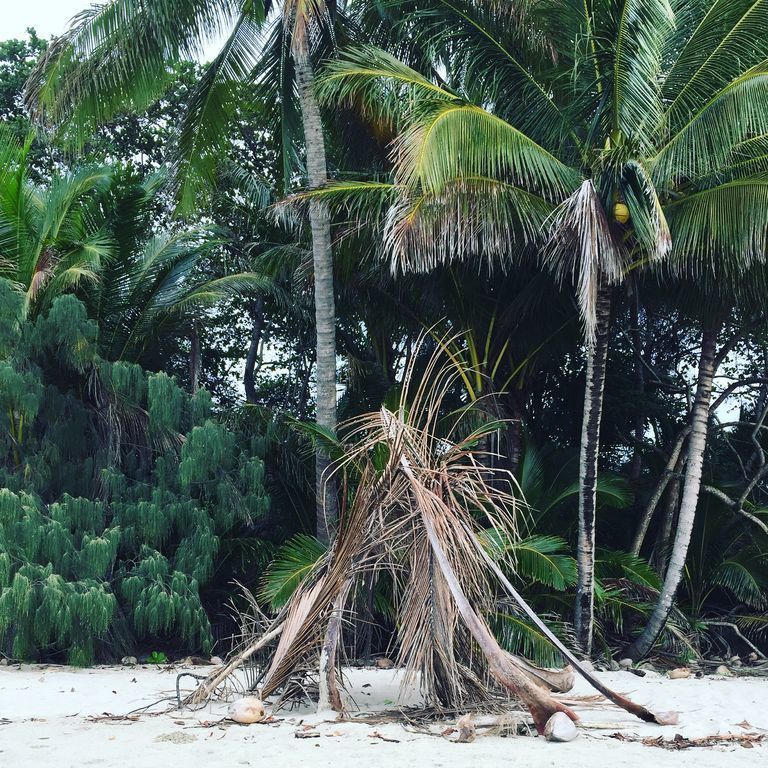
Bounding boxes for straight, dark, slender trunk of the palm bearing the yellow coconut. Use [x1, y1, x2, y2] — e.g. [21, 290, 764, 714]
[574, 278, 611, 656]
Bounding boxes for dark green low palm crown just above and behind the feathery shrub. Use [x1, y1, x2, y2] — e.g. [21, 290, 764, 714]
[87, 169, 274, 372]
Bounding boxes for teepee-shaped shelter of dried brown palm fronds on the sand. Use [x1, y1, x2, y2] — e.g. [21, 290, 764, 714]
[183, 334, 676, 732]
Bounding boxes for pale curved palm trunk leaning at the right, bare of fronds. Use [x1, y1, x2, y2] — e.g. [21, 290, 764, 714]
[626, 324, 719, 659]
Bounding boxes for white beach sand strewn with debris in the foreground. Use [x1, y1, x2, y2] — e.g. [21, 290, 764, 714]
[0, 665, 768, 768]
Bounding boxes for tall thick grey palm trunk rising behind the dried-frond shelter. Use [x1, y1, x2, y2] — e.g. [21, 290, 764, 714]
[294, 50, 338, 544]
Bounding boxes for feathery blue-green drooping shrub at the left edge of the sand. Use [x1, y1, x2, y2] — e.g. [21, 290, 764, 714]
[0, 281, 269, 664]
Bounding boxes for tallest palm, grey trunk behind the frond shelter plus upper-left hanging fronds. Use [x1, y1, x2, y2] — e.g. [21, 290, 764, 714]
[27, 0, 336, 540]
